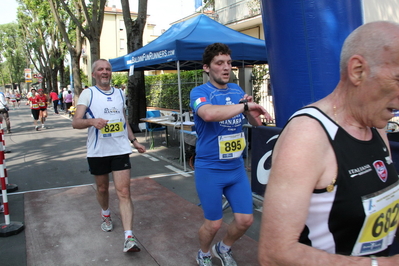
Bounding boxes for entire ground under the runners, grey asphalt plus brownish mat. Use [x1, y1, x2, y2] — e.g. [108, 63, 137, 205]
[0, 105, 260, 266]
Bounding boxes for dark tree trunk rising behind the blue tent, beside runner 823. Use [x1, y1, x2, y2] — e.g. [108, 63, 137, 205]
[121, 0, 147, 128]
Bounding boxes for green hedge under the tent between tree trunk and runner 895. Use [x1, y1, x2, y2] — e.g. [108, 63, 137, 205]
[145, 70, 203, 110]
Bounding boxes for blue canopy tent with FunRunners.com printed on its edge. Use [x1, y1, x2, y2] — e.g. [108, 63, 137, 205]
[109, 14, 267, 170]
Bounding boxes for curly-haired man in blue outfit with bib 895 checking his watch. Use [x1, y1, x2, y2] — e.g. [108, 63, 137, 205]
[190, 43, 271, 266]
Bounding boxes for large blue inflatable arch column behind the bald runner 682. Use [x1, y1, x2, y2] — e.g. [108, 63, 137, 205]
[262, 0, 363, 127]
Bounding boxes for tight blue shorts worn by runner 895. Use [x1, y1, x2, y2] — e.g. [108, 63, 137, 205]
[195, 167, 253, 221]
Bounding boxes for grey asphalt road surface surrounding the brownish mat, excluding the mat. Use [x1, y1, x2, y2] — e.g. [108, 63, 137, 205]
[0, 102, 261, 266]
